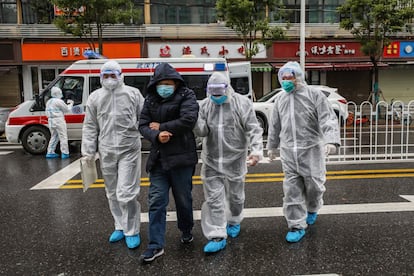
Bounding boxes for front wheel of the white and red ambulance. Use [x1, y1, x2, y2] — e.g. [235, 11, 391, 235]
[22, 126, 50, 155]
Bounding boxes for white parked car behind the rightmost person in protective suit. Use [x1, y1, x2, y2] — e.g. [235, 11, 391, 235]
[253, 85, 348, 133]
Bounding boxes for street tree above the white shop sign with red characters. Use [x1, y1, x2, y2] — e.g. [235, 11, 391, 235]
[216, 0, 285, 60]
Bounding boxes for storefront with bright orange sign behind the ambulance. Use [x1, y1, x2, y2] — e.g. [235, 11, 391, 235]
[22, 41, 141, 100]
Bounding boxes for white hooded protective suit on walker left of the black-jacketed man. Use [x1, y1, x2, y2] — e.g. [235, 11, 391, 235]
[82, 61, 144, 236]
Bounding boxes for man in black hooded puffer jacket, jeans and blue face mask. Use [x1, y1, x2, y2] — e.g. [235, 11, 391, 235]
[139, 63, 199, 262]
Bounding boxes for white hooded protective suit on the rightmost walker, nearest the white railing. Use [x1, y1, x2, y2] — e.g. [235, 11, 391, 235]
[267, 62, 340, 229]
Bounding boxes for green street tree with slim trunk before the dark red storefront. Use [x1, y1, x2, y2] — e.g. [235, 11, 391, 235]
[338, 0, 414, 106]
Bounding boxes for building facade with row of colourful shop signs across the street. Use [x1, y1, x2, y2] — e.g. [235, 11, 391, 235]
[0, 0, 414, 106]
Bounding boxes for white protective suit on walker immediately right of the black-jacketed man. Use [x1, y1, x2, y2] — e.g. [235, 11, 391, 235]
[194, 73, 263, 240]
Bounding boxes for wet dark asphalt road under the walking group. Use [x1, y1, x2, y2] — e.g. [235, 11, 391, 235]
[0, 144, 414, 275]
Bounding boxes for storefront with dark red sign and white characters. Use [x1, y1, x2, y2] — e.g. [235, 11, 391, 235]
[272, 40, 380, 102]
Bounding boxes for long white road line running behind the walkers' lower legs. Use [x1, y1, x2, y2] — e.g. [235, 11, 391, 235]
[141, 195, 414, 222]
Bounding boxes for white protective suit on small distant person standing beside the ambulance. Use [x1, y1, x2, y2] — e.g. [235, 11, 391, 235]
[45, 86, 73, 154]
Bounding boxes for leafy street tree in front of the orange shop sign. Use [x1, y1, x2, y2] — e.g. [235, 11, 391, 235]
[50, 0, 142, 54]
